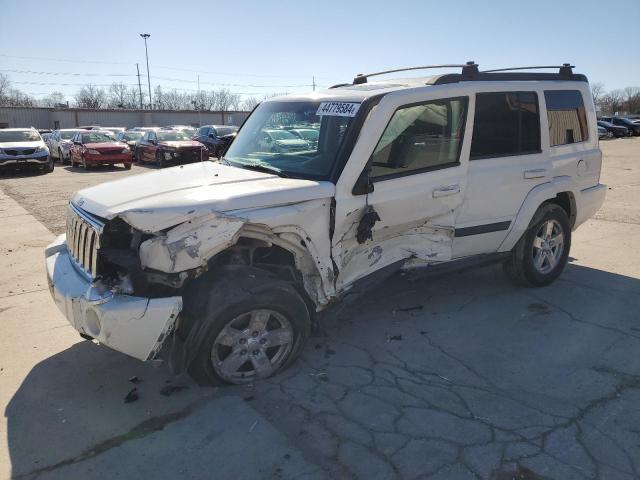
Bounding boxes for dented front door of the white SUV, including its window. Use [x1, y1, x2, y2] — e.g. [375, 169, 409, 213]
[332, 96, 468, 290]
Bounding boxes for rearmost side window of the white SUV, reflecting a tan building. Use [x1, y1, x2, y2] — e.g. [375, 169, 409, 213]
[544, 90, 589, 143]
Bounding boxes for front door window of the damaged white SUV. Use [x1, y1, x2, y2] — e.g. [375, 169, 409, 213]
[371, 97, 468, 181]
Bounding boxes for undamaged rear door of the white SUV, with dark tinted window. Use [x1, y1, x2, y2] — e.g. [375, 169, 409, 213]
[453, 84, 551, 258]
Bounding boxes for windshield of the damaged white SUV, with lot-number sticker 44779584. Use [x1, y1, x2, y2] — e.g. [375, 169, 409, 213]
[224, 101, 359, 179]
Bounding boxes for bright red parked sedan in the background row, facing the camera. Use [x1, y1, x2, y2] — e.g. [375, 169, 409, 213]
[70, 130, 133, 170]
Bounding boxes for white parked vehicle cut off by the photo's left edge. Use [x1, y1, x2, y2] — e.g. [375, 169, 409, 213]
[0, 128, 53, 173]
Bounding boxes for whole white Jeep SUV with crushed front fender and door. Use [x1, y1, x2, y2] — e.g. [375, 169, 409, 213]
[46, 63, 606, 383]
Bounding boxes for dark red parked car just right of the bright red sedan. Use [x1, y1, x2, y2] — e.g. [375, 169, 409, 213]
[136, 130, 209, 168]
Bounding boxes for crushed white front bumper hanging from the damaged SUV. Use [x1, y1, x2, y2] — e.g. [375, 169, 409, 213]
[45, 235, 182, 360]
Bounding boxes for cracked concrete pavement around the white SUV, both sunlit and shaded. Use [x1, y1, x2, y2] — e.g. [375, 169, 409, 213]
[0, 139, 640, 480]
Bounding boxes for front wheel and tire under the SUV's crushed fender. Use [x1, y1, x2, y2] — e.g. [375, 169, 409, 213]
[178, 265, 311, 385]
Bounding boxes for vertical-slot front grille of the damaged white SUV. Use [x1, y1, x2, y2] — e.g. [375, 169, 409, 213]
[67, 203, 104, 278]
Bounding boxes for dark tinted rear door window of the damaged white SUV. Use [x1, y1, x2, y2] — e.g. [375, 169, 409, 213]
[470, 92, 540, 160]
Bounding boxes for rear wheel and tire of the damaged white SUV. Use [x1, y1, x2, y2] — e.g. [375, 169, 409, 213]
[504, 203, 571, 287]
